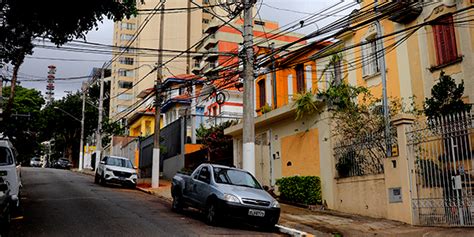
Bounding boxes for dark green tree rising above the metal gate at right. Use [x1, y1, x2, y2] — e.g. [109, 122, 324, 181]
[424, 71, 471, 118]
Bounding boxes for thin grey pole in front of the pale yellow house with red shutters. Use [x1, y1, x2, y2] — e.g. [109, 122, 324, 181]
[374, 0, 392, 157]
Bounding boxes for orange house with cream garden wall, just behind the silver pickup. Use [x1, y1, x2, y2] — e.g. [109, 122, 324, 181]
[225, 43, 328, 186]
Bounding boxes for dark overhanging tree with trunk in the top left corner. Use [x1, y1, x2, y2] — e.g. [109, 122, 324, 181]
[0, 0, 136, 116]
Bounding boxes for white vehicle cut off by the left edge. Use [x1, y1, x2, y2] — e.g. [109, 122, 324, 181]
[0, 138, 21, 207]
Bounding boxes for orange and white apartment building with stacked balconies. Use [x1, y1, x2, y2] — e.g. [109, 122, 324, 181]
[192, 18, 306, 125]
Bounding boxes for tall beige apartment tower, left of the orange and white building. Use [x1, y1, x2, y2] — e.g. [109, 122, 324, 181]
[110, 0, 209, 119]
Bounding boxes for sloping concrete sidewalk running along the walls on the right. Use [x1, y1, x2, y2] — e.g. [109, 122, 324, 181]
[76, 170, 474, 237]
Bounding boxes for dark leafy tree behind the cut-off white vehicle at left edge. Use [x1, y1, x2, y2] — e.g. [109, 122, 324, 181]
[0, 86, 44, 162]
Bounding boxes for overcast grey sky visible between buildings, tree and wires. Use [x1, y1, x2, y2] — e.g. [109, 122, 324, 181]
[10, 0, 353, 99]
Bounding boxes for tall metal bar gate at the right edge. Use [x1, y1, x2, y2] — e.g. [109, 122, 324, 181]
[406, 112, 474, 226]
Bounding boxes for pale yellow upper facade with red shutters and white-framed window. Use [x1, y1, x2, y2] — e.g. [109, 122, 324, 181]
[326, 0, 474, 106]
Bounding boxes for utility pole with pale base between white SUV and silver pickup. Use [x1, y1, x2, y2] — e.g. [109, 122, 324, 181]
[151, 0, 166, 188]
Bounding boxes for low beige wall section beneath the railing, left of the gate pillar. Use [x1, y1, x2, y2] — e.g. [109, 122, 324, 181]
[335, 174, 387, 218]
